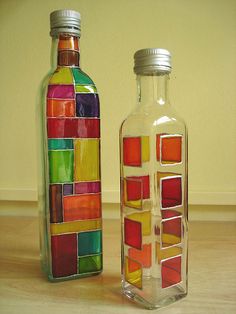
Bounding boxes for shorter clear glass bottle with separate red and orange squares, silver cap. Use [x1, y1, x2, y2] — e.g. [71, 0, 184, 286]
[120, 49, 188, 309]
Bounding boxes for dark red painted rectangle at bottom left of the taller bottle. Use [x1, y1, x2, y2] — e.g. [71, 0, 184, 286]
[51, 233, 77, 278]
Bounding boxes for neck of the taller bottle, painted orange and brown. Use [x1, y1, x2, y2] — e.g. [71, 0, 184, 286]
[51, 33, 80, 69]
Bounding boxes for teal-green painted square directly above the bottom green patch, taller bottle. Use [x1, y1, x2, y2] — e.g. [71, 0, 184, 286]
[78, 230, 102, 256]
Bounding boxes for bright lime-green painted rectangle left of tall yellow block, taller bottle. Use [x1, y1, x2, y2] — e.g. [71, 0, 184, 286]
[48, 150, 74, 183]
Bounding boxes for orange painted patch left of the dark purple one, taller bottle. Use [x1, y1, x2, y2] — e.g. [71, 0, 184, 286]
[47, 99, 75, 117]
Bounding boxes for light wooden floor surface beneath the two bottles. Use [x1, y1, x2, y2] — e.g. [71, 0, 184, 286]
[0, 217, 236, 314]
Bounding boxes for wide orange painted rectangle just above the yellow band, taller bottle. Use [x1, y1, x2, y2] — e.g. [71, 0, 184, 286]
[63, 194, 101, 221]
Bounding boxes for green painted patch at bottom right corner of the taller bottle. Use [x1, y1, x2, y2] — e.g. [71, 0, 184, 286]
[78, 254, 102, 274]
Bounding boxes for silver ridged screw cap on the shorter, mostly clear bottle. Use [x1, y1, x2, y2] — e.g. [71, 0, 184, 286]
[134, 48, 171, 74]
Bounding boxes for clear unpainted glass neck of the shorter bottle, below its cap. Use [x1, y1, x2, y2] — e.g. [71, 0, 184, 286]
[137, 72, 169, 106]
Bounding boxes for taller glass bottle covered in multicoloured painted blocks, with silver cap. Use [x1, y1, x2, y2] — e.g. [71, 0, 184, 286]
[37, 10, 102, 281]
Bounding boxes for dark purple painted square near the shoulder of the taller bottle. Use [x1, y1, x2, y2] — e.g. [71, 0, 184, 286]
[76, 94, 99, 118]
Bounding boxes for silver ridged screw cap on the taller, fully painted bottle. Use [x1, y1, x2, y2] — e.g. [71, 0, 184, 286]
[50, 10, 80, 37]
